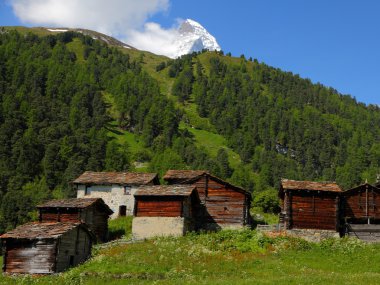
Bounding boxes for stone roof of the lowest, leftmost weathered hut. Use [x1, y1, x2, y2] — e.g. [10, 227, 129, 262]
[0, 222, 82, 239]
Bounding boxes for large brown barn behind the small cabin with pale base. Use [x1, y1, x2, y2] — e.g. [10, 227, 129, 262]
[164, 170, 252, 230]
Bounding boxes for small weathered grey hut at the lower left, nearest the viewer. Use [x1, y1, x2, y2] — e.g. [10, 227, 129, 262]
[0, 222, 96, 274]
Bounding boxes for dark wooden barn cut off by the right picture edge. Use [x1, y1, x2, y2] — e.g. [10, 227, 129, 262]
[341, 183, 380, 241]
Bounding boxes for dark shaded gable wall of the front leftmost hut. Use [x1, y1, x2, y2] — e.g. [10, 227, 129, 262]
[56, 227, 92, 272]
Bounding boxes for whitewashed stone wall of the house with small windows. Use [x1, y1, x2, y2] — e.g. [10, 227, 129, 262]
[77, 184, 137, 219]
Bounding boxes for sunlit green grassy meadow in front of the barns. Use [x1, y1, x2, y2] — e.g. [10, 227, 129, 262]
[0, 230, 380, 285]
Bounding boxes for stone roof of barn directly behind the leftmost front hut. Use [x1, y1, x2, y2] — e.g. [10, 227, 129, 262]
[37, 198, 113, 214]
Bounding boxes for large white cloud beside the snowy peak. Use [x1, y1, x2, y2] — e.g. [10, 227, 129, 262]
[9, 0, 186, 57]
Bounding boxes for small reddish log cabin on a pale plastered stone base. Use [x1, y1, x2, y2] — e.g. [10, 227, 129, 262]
[132, 185, 200, 239]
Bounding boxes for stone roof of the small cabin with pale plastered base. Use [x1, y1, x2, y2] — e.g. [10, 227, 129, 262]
[135, 185, 195, 196]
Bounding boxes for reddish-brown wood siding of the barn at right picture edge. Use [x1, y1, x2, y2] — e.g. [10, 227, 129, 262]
[342, 185, 380, 223]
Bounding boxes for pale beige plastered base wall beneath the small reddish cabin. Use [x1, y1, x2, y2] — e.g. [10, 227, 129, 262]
[132, 217, 191, 240]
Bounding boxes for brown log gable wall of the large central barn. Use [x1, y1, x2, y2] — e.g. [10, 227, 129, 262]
[203, 179, 246, 225]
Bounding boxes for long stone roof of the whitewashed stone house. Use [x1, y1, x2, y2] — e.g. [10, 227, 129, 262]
[73, 171, 158, 185]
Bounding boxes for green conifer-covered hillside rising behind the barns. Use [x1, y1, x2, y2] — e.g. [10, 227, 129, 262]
[0, 30, 380, 231]
